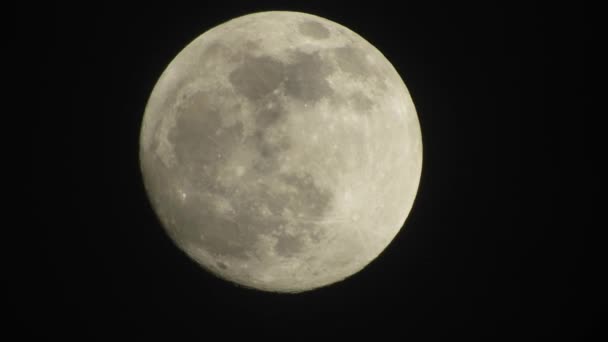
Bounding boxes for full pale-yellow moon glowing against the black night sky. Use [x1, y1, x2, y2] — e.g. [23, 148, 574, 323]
[139, 11, 422, 293]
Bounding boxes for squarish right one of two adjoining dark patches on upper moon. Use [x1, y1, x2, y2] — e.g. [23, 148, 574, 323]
[285, 51, 333, 102]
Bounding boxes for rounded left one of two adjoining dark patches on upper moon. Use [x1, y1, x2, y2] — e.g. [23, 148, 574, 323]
[228, 55, 285, 101]
